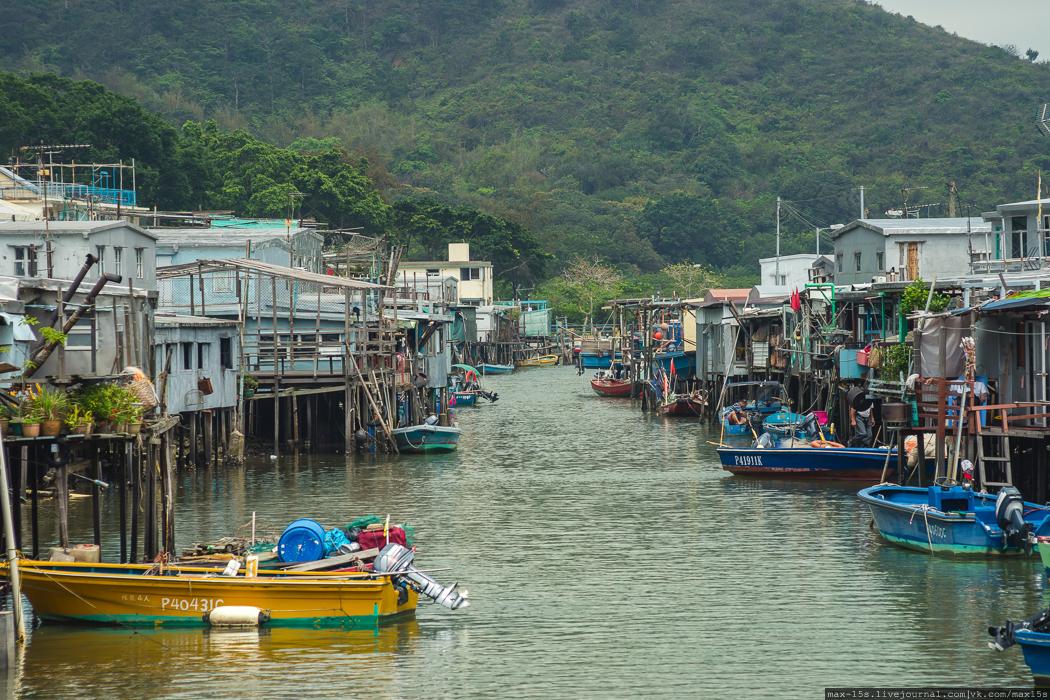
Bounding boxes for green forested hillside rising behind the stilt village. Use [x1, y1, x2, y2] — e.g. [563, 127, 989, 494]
[0, 0, 1050, 281]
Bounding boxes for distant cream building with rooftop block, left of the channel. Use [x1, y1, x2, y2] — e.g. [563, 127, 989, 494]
[398, 243, 492, 306]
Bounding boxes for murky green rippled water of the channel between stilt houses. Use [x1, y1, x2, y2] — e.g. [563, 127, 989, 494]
[6, 368, 1044, 698]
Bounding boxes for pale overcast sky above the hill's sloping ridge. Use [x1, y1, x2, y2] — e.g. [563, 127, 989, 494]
[877, 0, 1050, 61]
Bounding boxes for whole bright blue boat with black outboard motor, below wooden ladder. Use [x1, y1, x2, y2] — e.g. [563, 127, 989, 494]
[857, 484, 1050, 556]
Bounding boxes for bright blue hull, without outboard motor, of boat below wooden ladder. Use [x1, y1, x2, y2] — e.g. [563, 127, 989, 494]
[857, 485, 1050, 556]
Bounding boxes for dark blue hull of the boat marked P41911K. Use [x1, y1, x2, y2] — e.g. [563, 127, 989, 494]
[718, 447, 896, 482]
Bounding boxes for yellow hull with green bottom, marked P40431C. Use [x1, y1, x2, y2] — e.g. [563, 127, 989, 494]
[9, 560, 418, 629]
